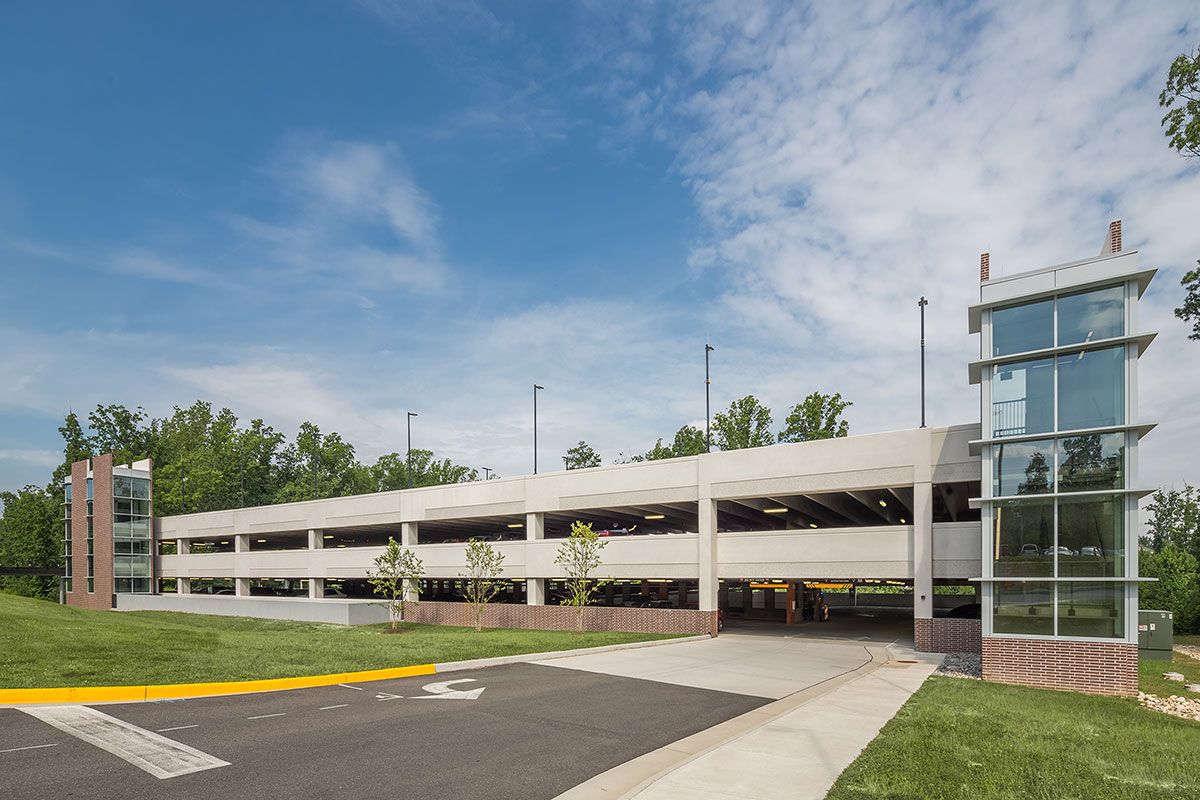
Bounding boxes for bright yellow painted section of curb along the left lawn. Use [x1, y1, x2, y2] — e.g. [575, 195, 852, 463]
[0, 664, 437, 705]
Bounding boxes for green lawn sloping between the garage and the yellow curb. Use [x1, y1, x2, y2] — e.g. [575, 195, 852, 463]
[0, 594, 673, 688]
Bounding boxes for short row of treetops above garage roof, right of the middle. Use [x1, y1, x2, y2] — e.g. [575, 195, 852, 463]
[563, 392, 853, 469]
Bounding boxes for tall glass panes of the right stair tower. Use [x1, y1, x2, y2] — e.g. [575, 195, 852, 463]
[990, 285, 1127, 638]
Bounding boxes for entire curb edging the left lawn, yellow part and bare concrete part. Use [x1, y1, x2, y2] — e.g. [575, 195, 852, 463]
[0, 634, 709, 708]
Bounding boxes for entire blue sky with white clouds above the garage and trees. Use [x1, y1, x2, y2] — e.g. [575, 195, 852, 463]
[0, 0, 1200, 496]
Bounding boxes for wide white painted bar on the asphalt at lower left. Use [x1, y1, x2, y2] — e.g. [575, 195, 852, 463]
[20, 705, 229, 778]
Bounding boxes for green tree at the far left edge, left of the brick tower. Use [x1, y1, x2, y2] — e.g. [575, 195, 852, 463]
[0, 486, 60, 600]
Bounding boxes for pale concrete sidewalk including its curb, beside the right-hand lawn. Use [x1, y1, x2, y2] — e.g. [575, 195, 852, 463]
[558, 644, 942, 800]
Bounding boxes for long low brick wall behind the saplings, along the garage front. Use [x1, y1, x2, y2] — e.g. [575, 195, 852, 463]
[404, 601, 716, 636]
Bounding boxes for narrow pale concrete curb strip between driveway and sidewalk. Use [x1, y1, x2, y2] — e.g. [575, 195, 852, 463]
[554, 642, 892, 800]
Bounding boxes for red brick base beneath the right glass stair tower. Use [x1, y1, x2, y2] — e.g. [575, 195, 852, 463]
[983, 637, 1138, 697]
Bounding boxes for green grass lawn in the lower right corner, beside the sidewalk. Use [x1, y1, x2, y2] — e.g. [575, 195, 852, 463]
[828, 678, 1200, 800]
